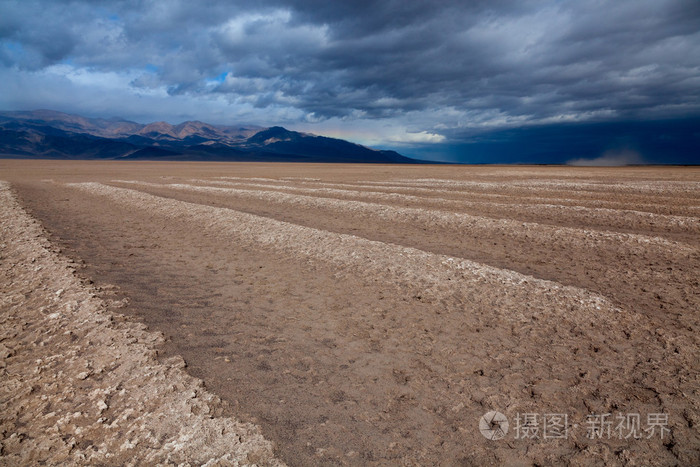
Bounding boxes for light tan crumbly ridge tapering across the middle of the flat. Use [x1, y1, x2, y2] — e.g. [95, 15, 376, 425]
[69, 182, 622, 310]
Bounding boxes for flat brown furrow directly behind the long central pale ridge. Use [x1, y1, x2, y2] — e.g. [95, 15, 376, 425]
[105, 178, 700, 329]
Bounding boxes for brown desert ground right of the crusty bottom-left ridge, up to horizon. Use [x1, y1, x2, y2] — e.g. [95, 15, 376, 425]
[0, 161, 700, 465]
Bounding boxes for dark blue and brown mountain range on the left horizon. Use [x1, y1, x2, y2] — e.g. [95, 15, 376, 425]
[0, 110, 423, 164]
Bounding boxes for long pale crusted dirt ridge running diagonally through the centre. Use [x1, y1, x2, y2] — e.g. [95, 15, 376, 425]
[69, 182, 628, 326]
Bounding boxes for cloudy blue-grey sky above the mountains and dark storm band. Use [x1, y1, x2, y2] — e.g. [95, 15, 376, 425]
[0, 0, 700, 163]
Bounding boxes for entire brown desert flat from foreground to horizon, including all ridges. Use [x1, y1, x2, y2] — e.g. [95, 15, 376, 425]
[0, 160, 700, 465]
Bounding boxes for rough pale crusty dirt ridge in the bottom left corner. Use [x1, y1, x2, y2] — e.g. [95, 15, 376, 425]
[0, 182, 283, 466]
